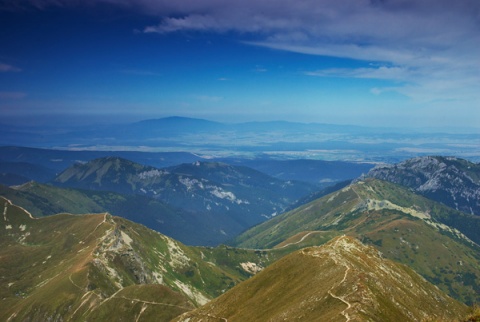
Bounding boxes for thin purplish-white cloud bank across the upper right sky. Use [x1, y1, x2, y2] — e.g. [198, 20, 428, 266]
[6, 0, 480, 101]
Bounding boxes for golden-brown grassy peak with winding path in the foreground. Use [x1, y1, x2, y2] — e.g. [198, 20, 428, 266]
[175, 236, 466, 322]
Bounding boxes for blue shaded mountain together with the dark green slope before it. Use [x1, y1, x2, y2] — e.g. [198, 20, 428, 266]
[3, 157, 318, 245]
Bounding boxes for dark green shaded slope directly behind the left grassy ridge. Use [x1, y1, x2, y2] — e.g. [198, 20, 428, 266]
[0, 182, 229, 245]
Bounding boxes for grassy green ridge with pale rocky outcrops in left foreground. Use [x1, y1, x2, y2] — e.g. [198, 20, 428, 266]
[0, 198, 275, 321]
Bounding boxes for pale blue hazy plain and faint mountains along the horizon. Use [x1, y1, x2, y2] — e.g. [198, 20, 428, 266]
[0, 117, 480, 161]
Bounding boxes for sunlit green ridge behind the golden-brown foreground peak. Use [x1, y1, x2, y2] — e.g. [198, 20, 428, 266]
[232, 180, 480, 304]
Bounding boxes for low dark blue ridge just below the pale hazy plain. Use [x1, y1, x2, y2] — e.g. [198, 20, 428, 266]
[0, 146, 374, 187]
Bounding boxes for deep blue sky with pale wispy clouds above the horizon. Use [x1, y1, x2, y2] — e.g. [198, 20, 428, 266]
[0, 0, 480, 129]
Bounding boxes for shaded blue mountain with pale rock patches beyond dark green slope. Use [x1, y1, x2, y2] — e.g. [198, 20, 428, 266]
[55, 157, 315, 245]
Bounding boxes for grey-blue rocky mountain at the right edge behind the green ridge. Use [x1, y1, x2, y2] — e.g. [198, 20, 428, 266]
[367, 157, 480, 215]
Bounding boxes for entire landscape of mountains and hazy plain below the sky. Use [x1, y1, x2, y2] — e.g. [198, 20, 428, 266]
[0, 117, 480, 321]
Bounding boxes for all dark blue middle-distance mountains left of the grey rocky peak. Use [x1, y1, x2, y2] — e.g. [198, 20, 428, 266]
[0, 147, 373, 245]
